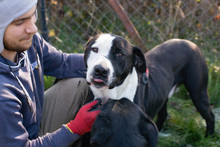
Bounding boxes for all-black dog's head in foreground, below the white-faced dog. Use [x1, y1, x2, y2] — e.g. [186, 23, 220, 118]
[90, 98, 158, 147]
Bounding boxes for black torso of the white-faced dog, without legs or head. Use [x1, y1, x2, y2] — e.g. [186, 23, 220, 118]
[135, 39, 205, 118]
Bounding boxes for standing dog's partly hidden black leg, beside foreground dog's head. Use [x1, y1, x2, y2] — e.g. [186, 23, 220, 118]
[156, 100, 168, 131]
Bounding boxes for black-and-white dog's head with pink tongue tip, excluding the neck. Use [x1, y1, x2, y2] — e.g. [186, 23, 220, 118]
[84, 34, 146, 89]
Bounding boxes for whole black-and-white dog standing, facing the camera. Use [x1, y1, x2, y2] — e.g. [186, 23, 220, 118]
[84, 34, 215, 139]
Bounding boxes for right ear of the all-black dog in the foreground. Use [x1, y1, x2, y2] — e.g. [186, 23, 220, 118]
[138, 113, 158, 147]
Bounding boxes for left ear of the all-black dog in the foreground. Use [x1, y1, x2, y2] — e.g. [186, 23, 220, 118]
[90, 117, 112, 146]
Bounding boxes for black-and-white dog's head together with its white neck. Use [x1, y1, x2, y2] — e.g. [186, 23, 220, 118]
[84, 34, 146, 102]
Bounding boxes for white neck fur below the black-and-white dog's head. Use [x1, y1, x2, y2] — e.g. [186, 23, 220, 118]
[91, 67, 138, 103]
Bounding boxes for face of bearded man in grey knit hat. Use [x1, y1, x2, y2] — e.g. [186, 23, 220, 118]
[3, 6, 37, 52]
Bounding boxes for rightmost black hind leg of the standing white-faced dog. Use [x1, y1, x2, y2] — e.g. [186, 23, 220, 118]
[184, 61, 215, 135]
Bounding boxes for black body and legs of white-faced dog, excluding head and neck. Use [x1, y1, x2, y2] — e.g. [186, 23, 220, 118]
[134, 39, 215, 135]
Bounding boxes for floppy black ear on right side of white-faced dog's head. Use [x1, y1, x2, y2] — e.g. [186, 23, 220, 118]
[133, 46, 146, 73]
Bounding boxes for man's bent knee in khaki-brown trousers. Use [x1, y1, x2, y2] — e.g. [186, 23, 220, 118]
[41, 78, 93, 134]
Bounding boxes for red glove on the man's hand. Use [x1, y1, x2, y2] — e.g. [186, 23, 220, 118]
[66, 100, 101, 136]
